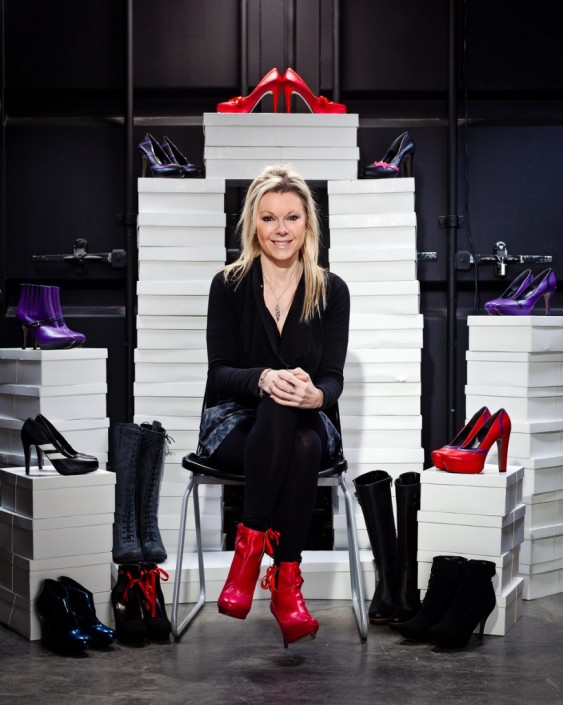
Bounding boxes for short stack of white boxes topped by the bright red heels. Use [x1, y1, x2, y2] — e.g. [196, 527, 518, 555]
[203, 113, 359, 181]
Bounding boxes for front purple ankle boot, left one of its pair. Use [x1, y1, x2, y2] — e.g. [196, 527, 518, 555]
[16, 284, 82, 350]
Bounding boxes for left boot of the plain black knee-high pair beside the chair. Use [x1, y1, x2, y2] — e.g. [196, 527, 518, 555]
[354, 470, 398, 624]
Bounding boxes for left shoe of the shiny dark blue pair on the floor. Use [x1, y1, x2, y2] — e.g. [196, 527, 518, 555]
[35, 578, 90, 654]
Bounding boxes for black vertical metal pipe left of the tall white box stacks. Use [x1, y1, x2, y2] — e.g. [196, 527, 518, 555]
[123, 0, 137, 421]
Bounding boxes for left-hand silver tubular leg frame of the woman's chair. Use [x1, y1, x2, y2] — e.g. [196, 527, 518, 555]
[170, 474, 209, 639]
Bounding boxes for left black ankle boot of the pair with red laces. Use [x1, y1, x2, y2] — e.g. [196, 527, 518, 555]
[111, 563, 147, 646]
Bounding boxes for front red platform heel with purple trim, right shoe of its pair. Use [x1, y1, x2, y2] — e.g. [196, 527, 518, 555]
[442, 409, 512, 475]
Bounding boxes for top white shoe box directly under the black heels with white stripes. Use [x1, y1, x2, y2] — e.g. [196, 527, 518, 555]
[0, 467, 115, 519]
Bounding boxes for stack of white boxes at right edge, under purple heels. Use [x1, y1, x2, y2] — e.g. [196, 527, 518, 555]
[466, 316, 563, 599]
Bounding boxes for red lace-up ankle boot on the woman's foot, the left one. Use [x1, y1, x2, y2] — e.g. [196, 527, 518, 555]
[217, 523, 279, 619]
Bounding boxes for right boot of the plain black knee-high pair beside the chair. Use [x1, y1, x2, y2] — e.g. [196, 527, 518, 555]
[389, 472, 420, 627]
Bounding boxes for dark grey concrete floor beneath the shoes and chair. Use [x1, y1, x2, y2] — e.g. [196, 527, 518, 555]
[0, 594, 563, 705]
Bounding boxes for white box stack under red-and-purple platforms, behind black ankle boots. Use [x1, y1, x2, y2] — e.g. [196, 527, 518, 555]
[418, 465, 526, 636]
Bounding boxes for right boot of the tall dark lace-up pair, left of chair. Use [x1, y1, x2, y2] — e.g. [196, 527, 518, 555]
[136, 421, 166, 563]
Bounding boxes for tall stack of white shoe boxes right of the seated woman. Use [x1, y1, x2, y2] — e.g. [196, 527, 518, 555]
[328, 178, 424, 592]
